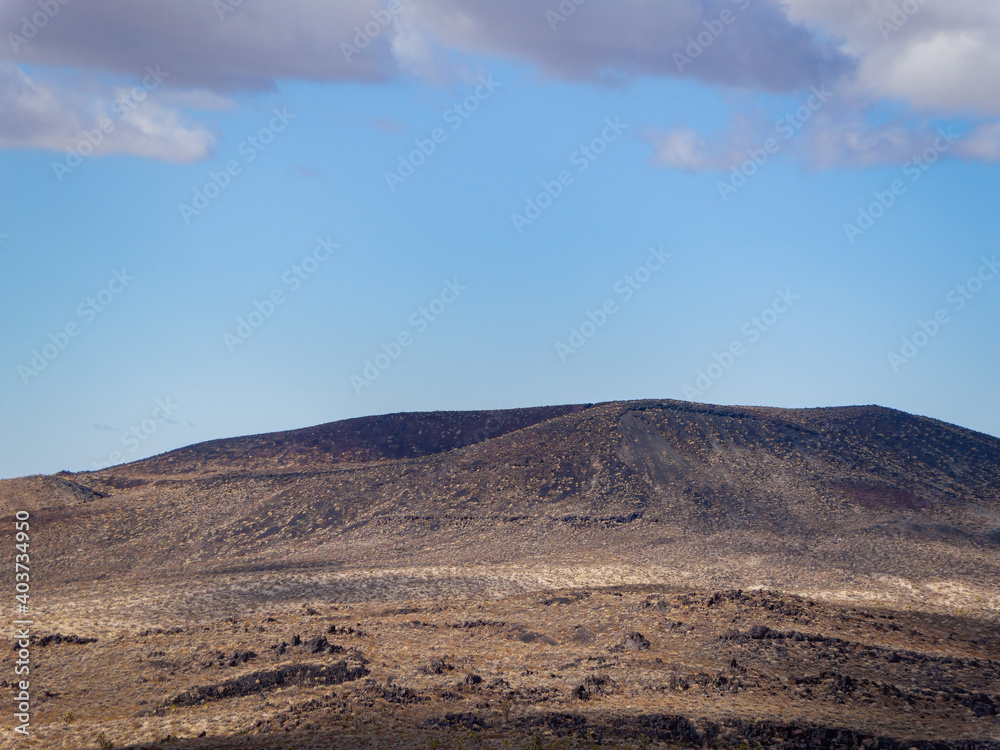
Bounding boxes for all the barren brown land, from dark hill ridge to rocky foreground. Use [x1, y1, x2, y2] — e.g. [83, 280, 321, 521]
[0, 400, 1000, 750]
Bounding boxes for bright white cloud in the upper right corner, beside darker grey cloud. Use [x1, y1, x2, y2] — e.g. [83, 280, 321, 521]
[650, 0, 1000, 170]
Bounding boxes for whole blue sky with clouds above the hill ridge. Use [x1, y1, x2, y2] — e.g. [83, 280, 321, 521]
[0, 0, 1000, 477]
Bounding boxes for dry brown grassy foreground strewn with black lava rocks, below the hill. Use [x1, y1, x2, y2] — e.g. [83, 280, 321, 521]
[0, 584, 1000, 750]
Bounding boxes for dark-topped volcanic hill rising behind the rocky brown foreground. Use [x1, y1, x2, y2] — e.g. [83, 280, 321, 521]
[0, 401, 1000, 606]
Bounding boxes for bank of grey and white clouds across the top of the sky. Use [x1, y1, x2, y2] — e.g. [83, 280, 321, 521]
[0, 0, 1000, 171]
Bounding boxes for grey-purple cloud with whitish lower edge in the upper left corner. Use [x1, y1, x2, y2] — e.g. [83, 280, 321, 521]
[0, 0, 398, 162]
